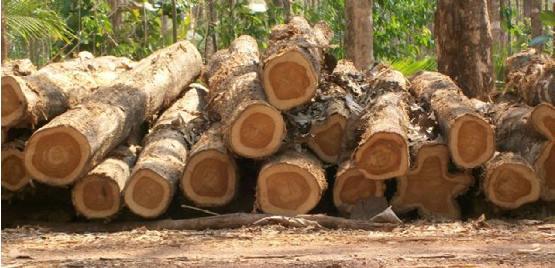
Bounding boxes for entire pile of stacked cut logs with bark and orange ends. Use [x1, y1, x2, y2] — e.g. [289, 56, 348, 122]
[1, 17, 555, 222]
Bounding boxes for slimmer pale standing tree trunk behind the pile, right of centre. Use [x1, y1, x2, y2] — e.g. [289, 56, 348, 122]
[345, 0, 374, 70]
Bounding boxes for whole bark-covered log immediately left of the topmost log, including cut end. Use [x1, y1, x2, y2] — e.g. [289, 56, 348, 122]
[207, 35, 286, 158]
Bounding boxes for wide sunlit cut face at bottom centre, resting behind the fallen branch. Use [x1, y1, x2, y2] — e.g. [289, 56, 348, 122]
[257, 163, 321, 215]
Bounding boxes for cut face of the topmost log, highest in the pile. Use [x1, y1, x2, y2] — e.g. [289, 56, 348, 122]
[263, 50, 318, 110]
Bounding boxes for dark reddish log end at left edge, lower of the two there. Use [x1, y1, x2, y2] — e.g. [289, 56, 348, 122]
[2, 140, 31, 192]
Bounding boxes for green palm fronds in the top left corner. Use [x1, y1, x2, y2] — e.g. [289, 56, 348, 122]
[2, 0, 72, 62]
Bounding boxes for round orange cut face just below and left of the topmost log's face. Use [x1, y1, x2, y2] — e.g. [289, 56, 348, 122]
[230, 104, 285, 158]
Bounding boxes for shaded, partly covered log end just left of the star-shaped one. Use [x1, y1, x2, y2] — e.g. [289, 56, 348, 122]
[333, 161, 385, 214]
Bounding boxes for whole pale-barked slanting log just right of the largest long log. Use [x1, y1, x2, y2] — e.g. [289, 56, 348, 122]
[124, 88, 208, 218]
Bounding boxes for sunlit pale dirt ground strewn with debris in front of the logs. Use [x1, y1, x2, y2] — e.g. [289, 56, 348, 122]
[2, 220, 555, 267]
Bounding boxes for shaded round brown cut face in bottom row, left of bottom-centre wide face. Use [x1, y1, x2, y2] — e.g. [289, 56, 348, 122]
[181, 150, 237, 207]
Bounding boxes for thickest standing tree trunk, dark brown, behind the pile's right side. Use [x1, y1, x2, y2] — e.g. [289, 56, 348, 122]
[434, 0, 495, 98]
